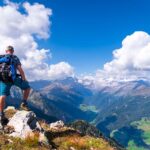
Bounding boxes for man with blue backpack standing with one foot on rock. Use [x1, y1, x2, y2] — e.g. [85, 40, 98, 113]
[0, 46, 30, 129]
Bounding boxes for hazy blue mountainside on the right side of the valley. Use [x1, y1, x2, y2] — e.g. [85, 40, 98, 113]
[84, 80, 150, 150]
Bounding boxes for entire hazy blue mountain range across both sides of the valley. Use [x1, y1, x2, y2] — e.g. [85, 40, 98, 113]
[7, 78, 150, 148]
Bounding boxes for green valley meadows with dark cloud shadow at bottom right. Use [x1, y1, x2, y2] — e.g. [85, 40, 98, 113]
[111, 118, 150, 150]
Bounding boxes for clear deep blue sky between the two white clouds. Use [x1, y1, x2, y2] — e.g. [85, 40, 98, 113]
[4, 0, 150, 74]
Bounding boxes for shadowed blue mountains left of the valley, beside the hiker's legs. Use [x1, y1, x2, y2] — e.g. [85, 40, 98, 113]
[8, 78, 95, 122]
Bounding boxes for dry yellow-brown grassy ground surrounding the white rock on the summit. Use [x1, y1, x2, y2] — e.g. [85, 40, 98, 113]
[0, 110, 116, 150]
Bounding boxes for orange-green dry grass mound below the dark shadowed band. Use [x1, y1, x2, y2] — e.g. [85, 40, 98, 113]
[54, 135, 114, 150]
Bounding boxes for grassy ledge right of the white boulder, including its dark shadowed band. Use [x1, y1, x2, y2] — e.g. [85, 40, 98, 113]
[41, 120, 116, 150]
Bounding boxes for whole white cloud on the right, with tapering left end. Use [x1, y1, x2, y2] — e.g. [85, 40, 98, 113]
[80, 31, 150, 88]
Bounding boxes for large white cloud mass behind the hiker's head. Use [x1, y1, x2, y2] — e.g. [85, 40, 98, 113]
[0, 0, 73, 80]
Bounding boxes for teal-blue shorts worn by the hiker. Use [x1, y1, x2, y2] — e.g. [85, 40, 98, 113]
[0, 77, 30, 96]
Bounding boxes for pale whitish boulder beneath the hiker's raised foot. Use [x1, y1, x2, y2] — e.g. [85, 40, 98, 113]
[4, 107, 48, 144]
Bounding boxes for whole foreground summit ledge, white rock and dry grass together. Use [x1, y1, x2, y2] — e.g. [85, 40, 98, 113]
[0, 107, 123, 150]
